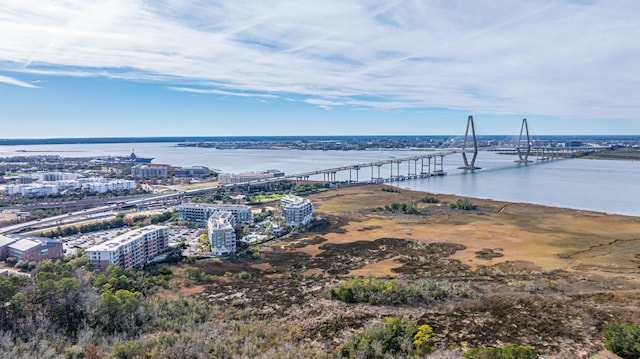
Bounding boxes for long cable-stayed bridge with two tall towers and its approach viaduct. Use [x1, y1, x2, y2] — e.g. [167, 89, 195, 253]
[0, 116, 606, 234]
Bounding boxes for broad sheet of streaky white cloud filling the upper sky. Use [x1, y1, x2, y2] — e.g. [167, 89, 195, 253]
[0, 0, 640, 118]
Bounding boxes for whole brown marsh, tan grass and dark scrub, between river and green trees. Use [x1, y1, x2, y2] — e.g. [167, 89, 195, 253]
[191, 185, 640, 358]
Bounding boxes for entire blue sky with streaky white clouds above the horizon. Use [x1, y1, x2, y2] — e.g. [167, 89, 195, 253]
[0, 0, 640, 138]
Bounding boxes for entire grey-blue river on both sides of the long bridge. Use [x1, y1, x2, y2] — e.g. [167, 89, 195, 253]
[0, 143, 640, 216]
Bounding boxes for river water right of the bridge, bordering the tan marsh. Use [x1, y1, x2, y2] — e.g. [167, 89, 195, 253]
[399, 152, 640, 216]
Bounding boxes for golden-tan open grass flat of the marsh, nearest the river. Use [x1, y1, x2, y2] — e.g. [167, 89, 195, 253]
[303, 185, 640, 275]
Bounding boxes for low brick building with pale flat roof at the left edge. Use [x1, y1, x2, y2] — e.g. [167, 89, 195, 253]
[0, 234, 64, 261]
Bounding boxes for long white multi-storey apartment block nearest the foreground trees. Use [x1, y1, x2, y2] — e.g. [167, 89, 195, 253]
[85, 225, 169, 270]
